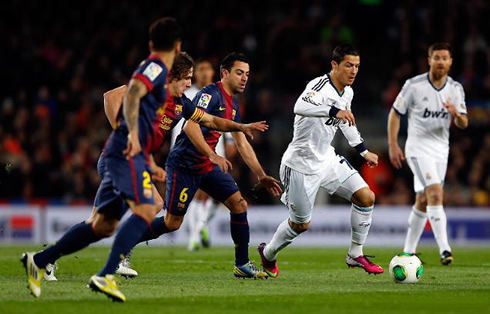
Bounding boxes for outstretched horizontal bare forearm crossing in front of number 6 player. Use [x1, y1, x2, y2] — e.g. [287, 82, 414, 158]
[200, 113, 269, 139]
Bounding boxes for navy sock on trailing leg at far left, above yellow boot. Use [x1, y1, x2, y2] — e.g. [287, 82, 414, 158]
[34, 221, 101, 268]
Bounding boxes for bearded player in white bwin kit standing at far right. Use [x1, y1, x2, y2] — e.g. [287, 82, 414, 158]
[388, 43, 468, 265]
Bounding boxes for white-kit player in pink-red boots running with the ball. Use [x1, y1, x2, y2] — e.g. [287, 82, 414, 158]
[258, 45, 383, 277]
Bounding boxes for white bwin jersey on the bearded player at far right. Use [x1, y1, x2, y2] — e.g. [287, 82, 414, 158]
[393, 73, 466, 160]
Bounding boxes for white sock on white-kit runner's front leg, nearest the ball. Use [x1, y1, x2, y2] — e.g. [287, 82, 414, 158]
[349, 204, 374, 258]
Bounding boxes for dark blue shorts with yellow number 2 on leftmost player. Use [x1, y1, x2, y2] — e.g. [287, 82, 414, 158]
[95, 134, 154, 218]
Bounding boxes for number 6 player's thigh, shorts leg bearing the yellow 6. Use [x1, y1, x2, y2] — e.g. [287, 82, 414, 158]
[165, 166, 201, 216]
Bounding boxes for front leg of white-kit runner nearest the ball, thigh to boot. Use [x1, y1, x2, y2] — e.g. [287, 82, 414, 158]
[332, 156, 384, 274]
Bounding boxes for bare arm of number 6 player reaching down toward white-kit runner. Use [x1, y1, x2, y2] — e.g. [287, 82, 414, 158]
[231, 132, 282, 196]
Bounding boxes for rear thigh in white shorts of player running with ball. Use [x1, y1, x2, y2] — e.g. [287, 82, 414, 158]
[280, 164, 321, 224]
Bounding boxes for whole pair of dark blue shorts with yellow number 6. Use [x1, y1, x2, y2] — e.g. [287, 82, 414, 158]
[165, 166, 238, 216]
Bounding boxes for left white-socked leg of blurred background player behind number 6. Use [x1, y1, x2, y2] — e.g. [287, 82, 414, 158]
[187, 190, 208, 251]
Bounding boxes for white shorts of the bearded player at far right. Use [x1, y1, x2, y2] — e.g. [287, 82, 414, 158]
[407, 156, 447, 193]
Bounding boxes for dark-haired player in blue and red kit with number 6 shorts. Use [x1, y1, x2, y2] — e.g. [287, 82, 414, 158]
[130, 53, 281, 278]
